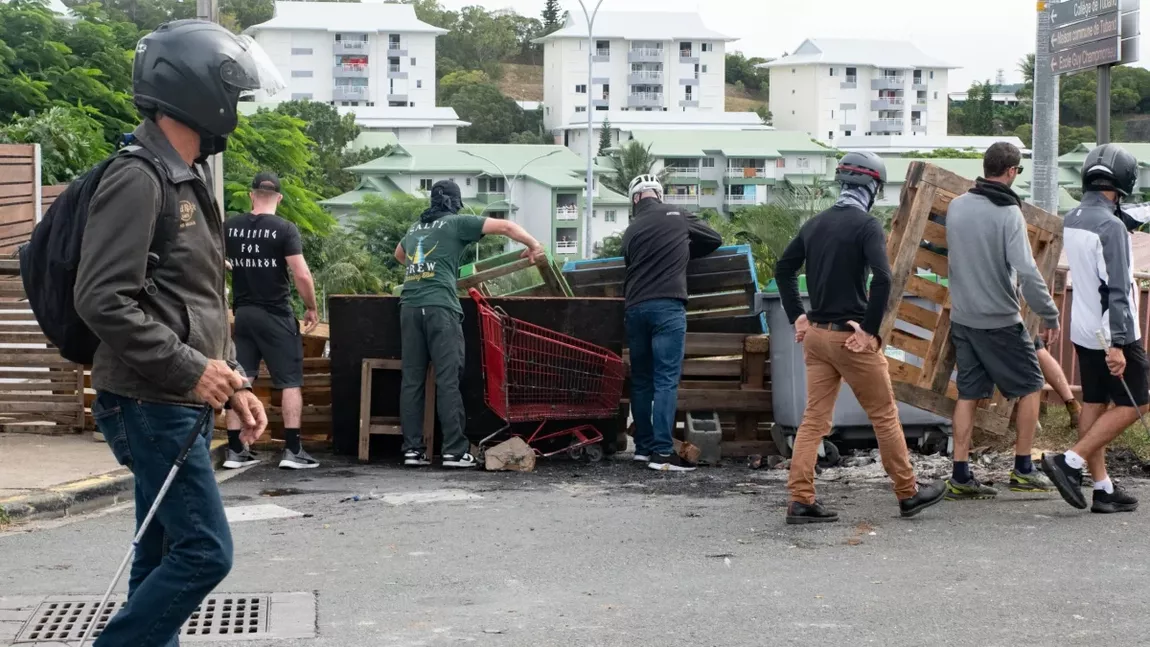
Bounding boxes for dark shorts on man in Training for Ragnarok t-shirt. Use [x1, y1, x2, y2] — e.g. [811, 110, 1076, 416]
[236, 306, 304, 388]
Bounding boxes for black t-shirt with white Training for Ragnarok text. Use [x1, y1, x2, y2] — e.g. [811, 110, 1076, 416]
[224, 214, 304, 316]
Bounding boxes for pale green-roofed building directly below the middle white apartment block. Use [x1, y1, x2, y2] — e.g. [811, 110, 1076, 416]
[633, 130, 836, 213]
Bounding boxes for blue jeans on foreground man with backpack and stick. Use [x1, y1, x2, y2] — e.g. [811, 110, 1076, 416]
[92, 391, 232, 647]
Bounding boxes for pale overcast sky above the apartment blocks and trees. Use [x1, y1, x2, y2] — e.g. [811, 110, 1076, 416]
[440, 0, 1150, 92]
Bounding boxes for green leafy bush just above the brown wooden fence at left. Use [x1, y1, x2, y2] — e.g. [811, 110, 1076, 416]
[0, 106, 112, 184]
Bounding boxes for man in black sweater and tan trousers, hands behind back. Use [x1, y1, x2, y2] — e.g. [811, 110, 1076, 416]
[775, 153, 945, 524]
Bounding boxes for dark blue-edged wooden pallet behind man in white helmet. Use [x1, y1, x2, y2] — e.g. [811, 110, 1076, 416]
[564, 245, 766, 333]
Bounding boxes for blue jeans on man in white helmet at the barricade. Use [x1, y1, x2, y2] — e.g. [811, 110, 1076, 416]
[626, 299, 687, 456]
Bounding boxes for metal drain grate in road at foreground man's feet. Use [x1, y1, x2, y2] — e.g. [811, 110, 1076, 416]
[16, 593, 277, 644]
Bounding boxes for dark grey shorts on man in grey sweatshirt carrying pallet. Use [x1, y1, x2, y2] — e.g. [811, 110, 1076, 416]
[950, 322, 1044, 400]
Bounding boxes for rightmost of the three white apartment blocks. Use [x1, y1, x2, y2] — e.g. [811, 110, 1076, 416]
[759, 38, 956, 144]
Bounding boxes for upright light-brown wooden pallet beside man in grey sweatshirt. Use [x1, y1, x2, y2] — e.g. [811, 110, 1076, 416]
[880, 162, 1063, 436]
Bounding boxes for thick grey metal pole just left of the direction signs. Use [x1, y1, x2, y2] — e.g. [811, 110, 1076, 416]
[1030, 1, 1058, 214]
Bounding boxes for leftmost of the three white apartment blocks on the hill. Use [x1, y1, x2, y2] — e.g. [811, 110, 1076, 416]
[246, 1, 447, 108]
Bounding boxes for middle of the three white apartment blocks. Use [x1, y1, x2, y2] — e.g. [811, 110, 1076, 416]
[536, 11, 735, 136]
